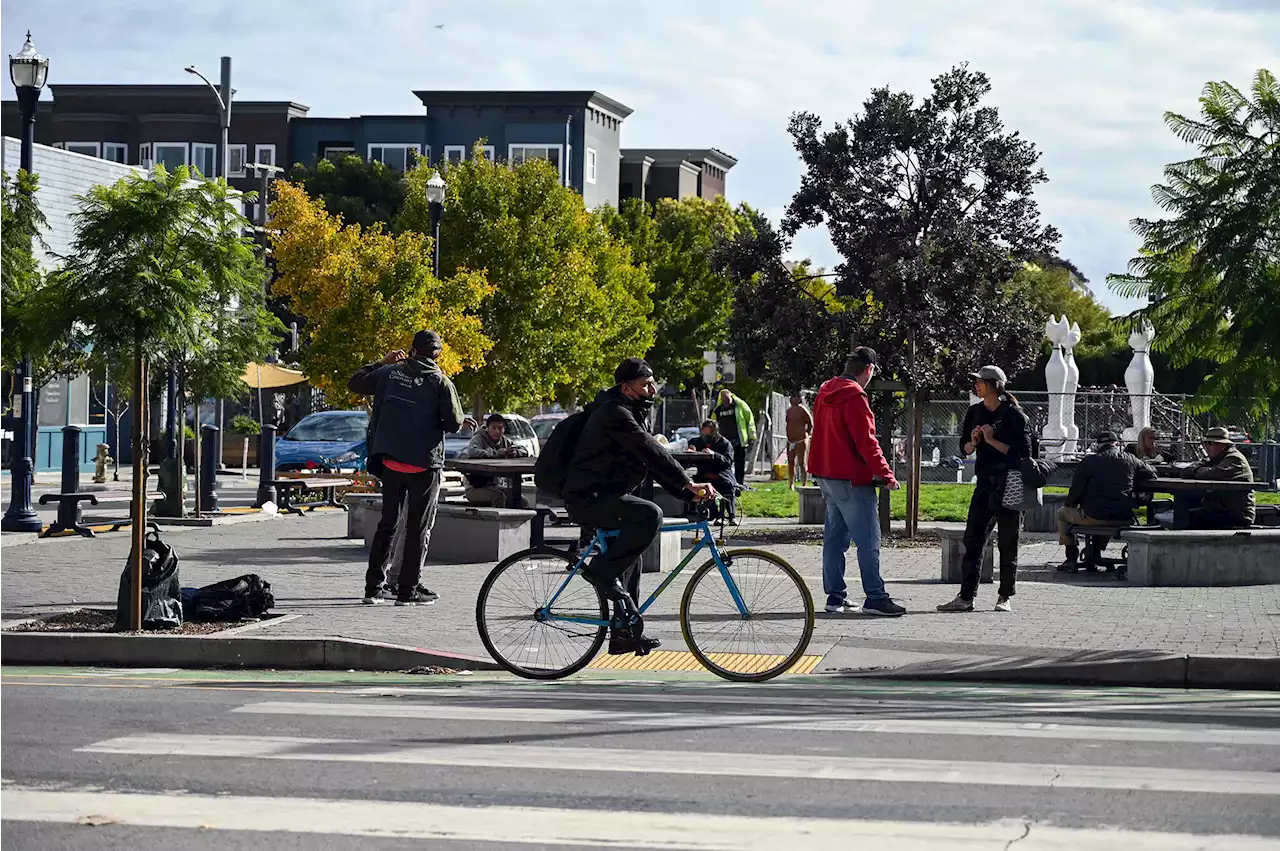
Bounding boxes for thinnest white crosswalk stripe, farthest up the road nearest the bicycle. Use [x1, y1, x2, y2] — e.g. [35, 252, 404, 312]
[230, 700, 1280, 747]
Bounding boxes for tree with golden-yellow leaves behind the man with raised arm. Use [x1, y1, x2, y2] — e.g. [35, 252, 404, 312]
[269, 182, 493, 406]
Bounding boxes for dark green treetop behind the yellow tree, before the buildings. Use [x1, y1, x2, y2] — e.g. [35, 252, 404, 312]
[289, 154, 407, 228]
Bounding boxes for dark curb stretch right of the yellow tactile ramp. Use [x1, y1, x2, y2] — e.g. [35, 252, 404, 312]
[827, 650, 1280, 691]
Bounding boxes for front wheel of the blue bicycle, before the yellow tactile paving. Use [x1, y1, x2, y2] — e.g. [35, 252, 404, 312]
[680, 549, 813, 682]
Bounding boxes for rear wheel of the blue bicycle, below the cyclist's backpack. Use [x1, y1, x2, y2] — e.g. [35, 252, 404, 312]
[476, 549, 609, 680]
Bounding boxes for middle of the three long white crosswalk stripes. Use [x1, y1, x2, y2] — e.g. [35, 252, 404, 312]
[78, 733, 1280, 795]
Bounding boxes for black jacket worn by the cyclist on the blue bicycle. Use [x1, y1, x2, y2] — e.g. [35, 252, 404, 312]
[564, 388, 689, 498]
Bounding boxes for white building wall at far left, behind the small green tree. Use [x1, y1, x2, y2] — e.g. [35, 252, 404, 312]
[0, 136, 145, 266]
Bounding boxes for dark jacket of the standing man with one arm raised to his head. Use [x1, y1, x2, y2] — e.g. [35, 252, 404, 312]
[347, 358, 463, 475]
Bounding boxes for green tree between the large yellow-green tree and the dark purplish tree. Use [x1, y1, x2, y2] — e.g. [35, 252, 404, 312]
[602, 197, 737, 384]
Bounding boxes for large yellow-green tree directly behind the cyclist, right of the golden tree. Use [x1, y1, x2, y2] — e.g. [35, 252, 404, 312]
[401, 155, 654, 411]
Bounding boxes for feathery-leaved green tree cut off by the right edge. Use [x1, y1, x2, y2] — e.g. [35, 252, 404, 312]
[1108, 69, 1280, 417]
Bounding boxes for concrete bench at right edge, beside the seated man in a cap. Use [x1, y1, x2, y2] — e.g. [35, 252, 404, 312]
[1124, 527, 1280, 587]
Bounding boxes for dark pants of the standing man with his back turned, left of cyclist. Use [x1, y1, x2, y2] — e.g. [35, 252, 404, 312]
[365, 470, 440, 600]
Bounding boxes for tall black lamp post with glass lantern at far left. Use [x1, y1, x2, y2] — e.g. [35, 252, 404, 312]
[0, 32, 49, 532]
